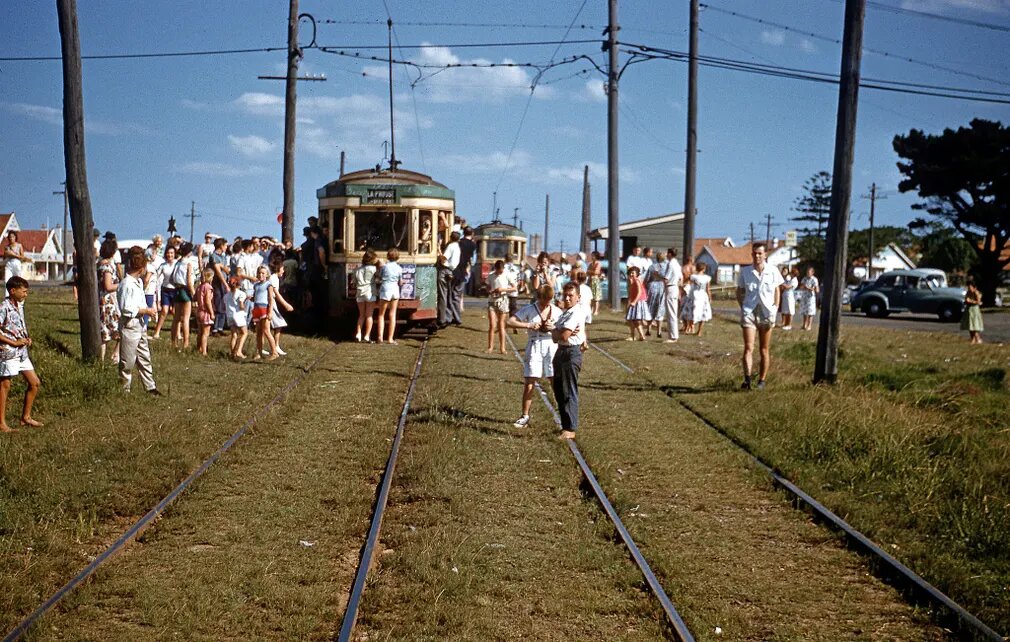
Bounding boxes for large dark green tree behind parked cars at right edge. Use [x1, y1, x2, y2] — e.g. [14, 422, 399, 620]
[893, 118, 1010, 305]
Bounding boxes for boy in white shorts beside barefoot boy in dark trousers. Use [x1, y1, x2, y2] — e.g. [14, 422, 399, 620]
[505, 286, 562, 428]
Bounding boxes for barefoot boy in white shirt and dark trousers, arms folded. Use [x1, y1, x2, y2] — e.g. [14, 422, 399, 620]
[550, 282, 586, 439]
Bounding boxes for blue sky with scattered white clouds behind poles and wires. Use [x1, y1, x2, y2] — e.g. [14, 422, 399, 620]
[0, 0, 1010, 249]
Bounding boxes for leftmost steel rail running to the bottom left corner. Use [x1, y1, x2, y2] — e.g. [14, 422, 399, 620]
[3, 347, 332, 642]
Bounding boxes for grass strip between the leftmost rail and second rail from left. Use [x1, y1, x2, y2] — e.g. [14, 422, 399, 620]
[32, 344, 416, 640]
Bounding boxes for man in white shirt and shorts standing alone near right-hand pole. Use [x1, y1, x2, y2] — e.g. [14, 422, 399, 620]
[736, 241, 783, 390]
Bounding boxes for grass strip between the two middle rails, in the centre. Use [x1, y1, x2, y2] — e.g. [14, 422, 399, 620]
[359, 329, 664, 640]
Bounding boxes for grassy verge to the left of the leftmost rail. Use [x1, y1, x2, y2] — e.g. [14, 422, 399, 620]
[0, 289, 324, 633]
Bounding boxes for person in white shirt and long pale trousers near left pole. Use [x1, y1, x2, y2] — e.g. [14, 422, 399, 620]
[117, 252, 161, 397]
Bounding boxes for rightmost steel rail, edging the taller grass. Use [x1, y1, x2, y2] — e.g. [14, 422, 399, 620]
[592, 344, 1006, 642]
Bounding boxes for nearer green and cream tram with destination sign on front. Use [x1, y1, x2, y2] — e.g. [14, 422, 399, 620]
[316, 168, 456, 327]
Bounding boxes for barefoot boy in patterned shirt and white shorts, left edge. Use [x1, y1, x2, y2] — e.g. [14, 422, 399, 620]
[0, 277, 42, 432]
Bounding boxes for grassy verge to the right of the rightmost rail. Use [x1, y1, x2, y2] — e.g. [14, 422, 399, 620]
[595, 308, 1010, 634]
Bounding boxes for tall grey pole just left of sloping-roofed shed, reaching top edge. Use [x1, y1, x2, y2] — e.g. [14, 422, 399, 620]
[606, 0, 621, 310]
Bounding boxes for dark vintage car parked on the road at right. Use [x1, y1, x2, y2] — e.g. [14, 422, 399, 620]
[849, 269, 965, 321]
